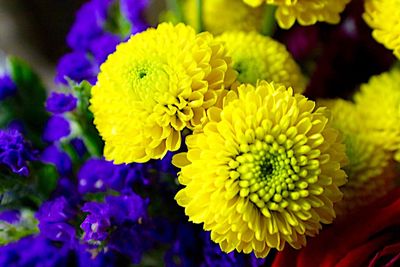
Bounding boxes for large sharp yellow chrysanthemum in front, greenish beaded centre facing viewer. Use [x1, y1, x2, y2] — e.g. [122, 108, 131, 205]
[173, 81, 346, 257]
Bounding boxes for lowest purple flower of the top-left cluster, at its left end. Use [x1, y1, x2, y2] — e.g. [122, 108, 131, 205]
[56, 51, 98, 84]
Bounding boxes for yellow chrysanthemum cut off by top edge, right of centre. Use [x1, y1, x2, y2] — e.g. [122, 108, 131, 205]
[243, 0, 350, 29]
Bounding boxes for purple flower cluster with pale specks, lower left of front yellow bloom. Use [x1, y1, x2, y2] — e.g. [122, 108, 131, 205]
[81, 192, 148, 263]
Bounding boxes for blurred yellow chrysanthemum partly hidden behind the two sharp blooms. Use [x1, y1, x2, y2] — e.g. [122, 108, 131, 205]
[216, 31, 306, 93]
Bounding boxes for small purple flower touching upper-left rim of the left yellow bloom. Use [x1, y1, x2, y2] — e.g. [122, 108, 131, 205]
[90, 33, 121, 64]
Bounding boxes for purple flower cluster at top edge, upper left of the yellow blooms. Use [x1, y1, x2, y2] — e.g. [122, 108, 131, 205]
[56, 0, 149, 84]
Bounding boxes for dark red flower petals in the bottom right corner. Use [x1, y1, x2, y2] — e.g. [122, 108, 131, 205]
[272, 188, 400, 267]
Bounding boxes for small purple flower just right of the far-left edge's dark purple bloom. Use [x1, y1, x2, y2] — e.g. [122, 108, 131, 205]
[40, 145, 72, 175]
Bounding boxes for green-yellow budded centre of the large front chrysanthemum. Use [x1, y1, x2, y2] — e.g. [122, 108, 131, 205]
[229, 135, 320, 216]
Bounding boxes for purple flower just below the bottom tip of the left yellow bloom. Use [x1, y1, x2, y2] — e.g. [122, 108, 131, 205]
[78, 159, 143, 194]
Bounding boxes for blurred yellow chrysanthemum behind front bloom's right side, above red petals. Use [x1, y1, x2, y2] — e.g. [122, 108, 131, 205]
[318, 99, 394, 215]
